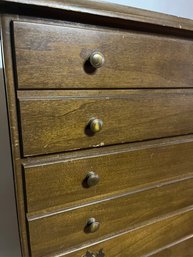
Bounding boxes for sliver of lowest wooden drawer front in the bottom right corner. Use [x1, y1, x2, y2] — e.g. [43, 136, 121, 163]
[151, 236, 193, 257]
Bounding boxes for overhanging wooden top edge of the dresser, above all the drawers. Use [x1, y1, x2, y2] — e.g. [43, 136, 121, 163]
[0, 0, 193, 33]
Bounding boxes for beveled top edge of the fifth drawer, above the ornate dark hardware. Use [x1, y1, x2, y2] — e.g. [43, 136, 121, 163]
[45, 205, 193, 257]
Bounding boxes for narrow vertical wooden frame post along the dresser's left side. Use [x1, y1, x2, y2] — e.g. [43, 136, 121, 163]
[0, 15, 29, 257]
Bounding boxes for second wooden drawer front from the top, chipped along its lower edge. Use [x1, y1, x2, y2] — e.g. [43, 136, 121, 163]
[18, 89, 193, 156]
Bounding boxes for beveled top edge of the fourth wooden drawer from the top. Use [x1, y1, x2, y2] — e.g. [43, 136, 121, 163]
[26, 173, 193, 222]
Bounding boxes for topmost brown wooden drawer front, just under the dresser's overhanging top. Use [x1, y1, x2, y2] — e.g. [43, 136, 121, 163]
[14, 21, 193, 88]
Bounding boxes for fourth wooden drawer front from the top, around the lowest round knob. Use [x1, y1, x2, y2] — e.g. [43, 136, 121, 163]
[28, 178, 193, 256]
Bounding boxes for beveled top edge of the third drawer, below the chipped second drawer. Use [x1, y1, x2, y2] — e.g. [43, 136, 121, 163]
[22, 135, 193, 168]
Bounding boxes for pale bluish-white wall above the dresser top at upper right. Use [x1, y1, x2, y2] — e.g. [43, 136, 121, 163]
[105, 0, 193, 19]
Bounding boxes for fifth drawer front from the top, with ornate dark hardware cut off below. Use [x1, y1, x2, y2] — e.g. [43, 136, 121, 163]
[63, 210, 193, 257]
